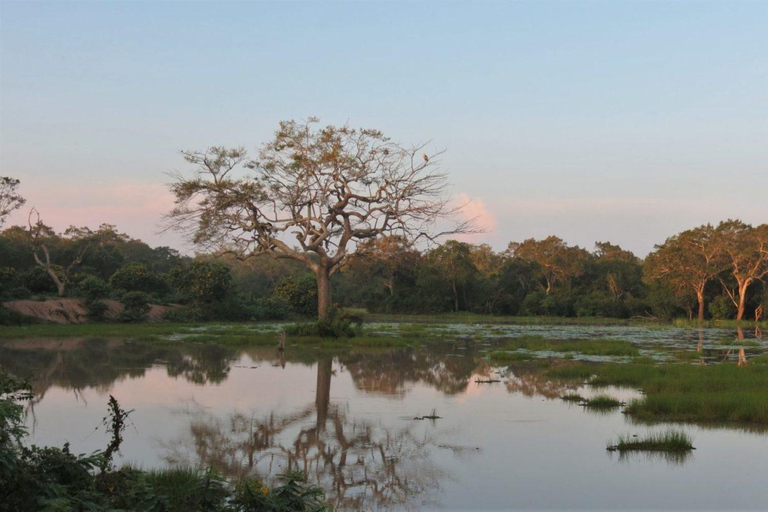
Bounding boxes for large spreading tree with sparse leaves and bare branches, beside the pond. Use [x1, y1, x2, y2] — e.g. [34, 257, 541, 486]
[169, 119, 468, 318]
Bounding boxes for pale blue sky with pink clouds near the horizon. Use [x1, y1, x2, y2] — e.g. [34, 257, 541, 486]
[0, 0, 768, 256]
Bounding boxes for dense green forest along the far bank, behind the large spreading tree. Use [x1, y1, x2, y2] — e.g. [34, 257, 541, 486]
[0, 178, 768, 323]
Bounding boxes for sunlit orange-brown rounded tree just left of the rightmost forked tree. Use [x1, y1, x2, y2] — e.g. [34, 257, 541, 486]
[644, 224, 725, 321]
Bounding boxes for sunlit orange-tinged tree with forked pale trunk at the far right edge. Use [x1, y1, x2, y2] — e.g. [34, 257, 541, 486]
[717, 220, 768, 320]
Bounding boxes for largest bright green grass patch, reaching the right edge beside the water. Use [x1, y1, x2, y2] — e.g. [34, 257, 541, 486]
[547, 363, 768, 425]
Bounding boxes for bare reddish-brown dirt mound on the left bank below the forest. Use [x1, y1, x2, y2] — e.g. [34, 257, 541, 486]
[3, 299, 168, 324]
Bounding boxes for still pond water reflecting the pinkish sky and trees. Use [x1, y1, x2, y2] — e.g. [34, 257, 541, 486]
[0, 328, 768, 510]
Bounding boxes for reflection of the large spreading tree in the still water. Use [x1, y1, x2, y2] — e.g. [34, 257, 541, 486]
[165, 357, 446, 510]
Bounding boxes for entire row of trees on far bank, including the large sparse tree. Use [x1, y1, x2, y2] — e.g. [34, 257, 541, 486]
[0, 118, 768, 320]
